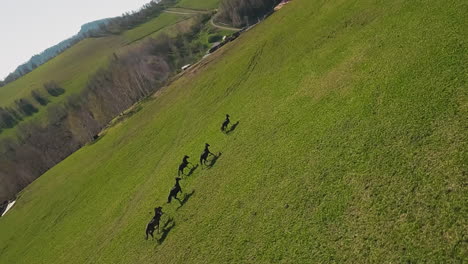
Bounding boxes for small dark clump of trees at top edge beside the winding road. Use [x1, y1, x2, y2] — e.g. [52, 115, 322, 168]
[217, 0, 281, 27]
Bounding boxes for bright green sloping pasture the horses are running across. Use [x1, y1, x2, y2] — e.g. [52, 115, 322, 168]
[0, 0, 468, 263]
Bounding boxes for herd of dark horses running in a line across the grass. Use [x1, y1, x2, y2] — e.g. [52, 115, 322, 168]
[146, 114, 239, 240]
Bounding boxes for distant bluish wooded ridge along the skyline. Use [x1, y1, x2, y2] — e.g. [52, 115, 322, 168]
[0, 0, 177, 87]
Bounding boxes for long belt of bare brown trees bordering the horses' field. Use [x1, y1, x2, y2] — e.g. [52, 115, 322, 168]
[0, 13, 209, 200]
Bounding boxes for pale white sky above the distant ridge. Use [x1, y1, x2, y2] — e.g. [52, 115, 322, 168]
[0, 0, 150, 80]
